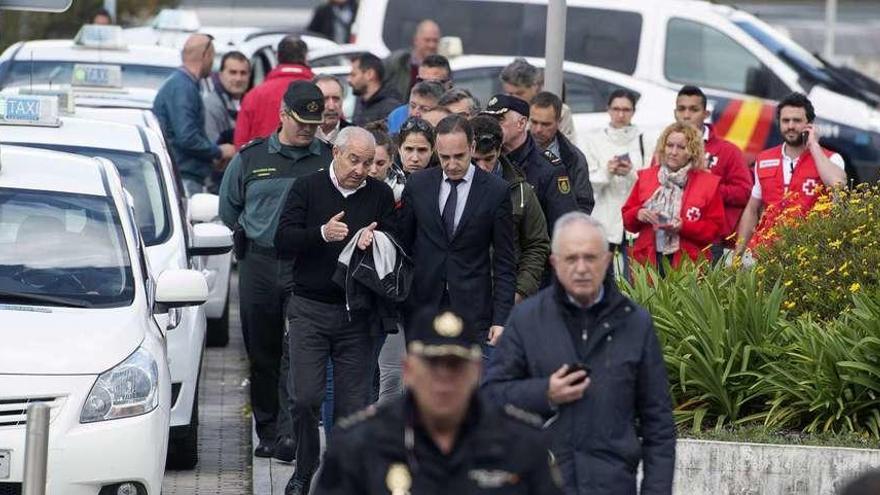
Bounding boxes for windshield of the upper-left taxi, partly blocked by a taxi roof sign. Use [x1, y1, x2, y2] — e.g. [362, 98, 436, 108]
[2, 60, 175, 90]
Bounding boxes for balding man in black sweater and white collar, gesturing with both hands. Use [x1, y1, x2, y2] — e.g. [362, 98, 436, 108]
[275, 127, 395, 494]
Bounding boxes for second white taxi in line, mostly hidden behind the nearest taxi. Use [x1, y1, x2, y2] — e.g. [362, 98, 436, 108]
[0, 96, 232, 468]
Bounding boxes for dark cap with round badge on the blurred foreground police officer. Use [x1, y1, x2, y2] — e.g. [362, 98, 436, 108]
[407, 309, 482, 361]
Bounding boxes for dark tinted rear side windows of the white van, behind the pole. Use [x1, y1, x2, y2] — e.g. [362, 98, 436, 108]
[382, 0, 642, 74]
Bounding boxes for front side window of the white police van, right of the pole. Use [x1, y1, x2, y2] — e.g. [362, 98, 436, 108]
[665, 19, 785, 99]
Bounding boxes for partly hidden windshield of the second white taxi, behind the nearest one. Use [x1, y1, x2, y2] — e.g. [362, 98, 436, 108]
[12, 143, 171, 246]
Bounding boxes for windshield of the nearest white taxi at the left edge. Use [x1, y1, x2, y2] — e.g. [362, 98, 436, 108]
[0, 188, 134, 307]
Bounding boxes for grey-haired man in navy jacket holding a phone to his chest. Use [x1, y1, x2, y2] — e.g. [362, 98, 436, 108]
[483, 212, 675, 495]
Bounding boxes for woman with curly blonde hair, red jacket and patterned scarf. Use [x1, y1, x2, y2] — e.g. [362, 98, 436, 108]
[622, 123, 724, 273]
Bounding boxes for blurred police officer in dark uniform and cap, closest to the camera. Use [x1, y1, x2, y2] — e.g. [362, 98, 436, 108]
[315, 311, 562, 495]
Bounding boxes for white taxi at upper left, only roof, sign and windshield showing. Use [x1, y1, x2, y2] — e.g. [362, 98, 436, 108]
[0, 25, 181, 89]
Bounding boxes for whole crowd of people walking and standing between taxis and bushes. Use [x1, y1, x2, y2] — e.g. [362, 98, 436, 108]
[154, 14, 846, 494]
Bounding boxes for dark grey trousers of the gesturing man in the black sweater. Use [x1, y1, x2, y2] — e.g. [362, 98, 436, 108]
[287, 295, 374, 483]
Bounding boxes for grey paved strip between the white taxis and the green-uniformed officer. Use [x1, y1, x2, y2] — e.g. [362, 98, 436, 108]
[162, 274, 251, 495]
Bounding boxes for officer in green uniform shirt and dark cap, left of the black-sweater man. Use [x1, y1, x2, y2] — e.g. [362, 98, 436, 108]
[220, 81, 333, 462]
